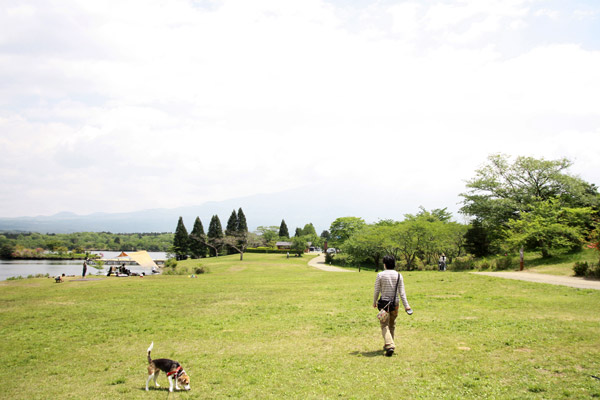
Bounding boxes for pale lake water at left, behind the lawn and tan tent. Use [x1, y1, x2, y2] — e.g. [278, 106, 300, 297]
[0, 251, 166, 281]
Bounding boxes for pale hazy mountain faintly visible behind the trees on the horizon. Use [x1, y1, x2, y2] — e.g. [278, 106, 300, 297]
[0, 185, 440, 234]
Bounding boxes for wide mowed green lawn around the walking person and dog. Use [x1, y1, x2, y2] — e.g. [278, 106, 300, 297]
[0, 254, 600, 400]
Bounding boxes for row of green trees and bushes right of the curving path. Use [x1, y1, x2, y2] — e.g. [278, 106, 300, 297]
[330, 154, 600, 270]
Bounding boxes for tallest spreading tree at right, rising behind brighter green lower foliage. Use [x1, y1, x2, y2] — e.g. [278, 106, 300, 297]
[461, 154, 600, 251]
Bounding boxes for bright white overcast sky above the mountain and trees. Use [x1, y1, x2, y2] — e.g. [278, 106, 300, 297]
[0, 0, 600, 222]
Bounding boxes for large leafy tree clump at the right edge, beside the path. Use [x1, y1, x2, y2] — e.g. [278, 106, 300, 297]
[461, 155, 600, 256]
